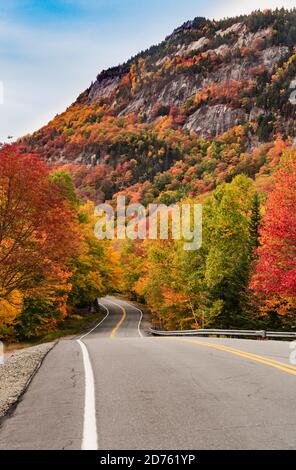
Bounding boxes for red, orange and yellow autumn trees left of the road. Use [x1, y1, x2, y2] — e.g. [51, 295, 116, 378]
[0, 145, 119, 337]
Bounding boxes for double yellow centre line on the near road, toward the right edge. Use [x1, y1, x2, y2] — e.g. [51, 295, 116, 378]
[174, 338, 296, 375]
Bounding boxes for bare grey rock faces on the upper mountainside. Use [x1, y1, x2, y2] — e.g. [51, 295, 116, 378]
[77, 17, 289, 138]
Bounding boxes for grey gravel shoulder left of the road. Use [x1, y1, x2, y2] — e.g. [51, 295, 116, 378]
[0, 342, 56, 418]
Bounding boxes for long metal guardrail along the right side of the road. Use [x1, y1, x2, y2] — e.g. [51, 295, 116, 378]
[150, 328, 296, 339]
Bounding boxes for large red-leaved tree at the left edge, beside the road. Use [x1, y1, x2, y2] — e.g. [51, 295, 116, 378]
[0, 145, 80, 299]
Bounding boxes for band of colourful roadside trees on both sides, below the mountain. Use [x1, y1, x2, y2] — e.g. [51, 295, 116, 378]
[0, 145, 296, 340]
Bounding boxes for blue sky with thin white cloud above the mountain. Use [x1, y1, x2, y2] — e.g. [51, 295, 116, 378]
[0, 0, 296, 141]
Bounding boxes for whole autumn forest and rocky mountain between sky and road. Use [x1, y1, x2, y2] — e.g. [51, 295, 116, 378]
[0, 9, 296, 341]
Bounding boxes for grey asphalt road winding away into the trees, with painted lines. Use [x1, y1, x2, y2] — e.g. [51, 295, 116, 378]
[0, 297, 296, 450]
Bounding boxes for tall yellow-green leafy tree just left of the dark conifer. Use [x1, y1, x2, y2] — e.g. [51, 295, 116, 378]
[204, 175, 254, 328]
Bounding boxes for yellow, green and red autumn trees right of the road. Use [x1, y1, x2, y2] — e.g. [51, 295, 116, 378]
[122, 151, 296, 330]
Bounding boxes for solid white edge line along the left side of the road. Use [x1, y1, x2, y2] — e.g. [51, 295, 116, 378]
[76, 302, 110, 450]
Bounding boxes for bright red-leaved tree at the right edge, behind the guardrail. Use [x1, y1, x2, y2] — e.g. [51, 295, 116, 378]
[251, 151, 296, 313]
